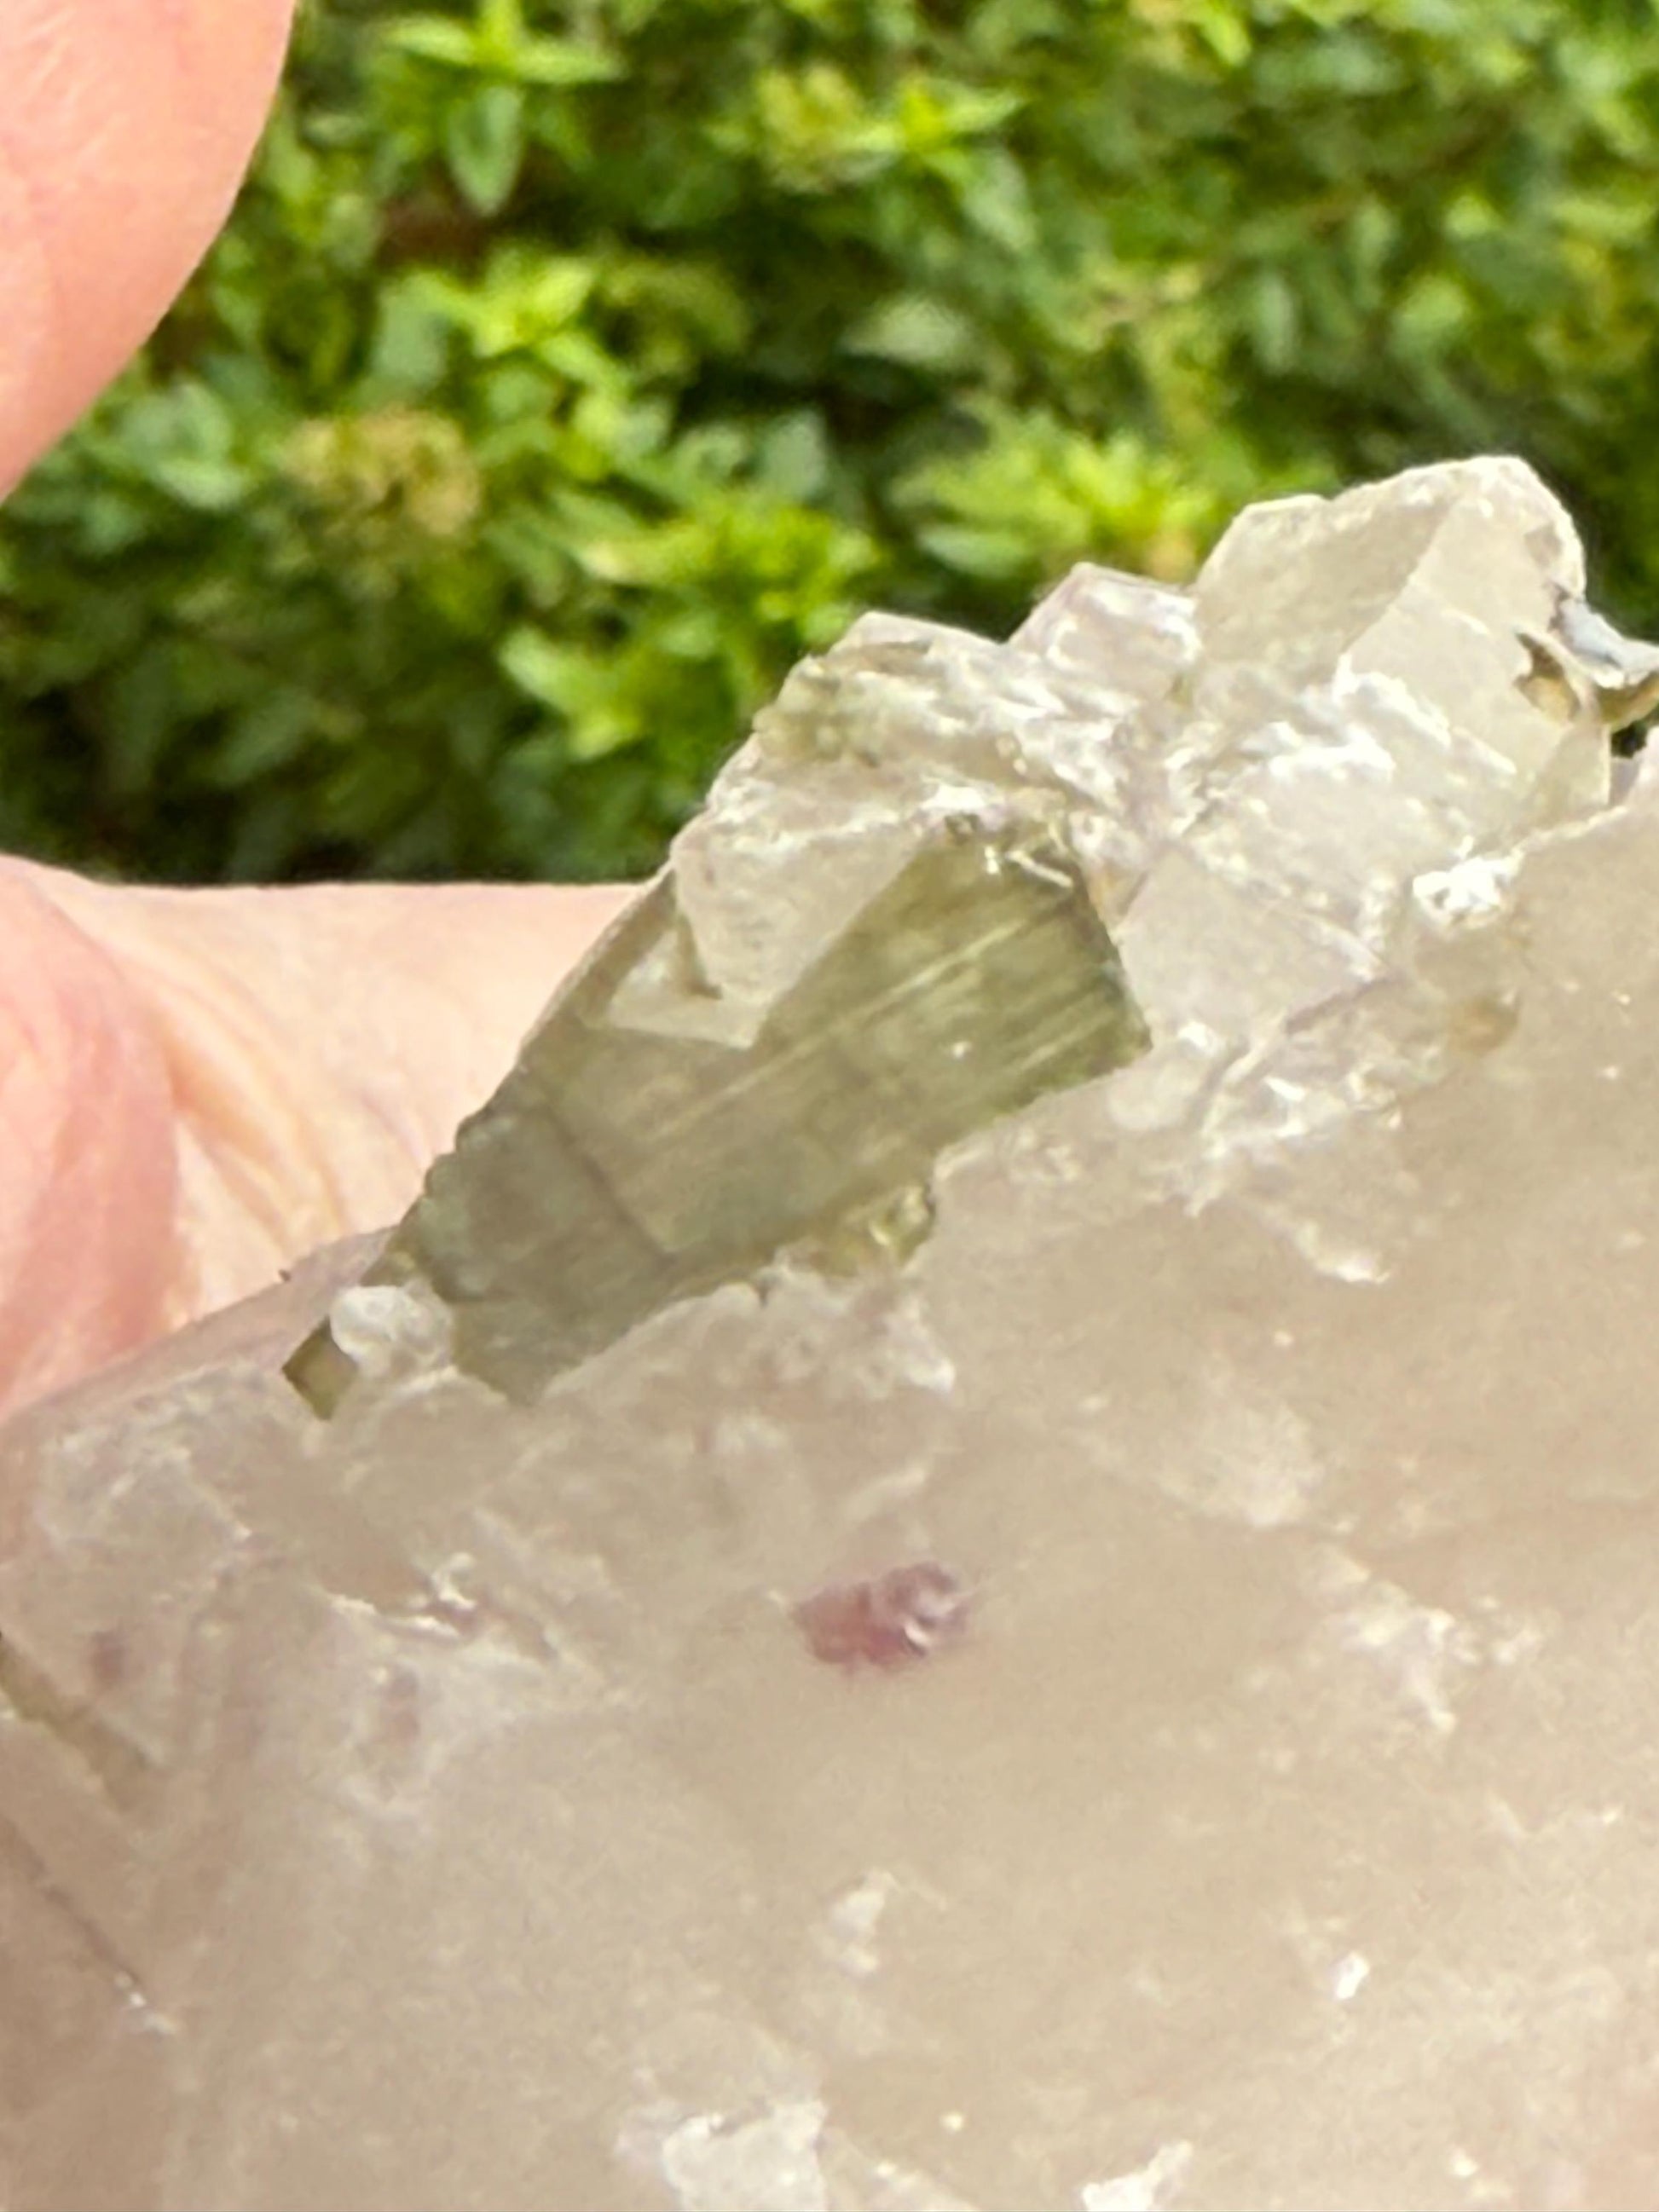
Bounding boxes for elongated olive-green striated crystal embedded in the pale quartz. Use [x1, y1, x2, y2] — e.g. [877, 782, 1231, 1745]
[287, 821, 1146, 1412]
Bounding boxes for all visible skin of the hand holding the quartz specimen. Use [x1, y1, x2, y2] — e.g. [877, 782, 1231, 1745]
[0, 0, 626, 1416]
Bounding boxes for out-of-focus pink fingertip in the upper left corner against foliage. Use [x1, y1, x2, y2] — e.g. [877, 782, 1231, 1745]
[0, 0, 292, 494]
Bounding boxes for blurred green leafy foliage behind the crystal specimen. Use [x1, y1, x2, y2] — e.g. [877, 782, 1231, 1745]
[0, 0, 1659, 878]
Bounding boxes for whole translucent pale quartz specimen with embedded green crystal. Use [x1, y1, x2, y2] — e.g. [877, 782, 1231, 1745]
[16, 460, 1659, 2212]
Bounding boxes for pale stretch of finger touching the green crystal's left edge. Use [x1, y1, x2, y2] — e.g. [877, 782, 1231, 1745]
[11, 863, 630, 1415]
